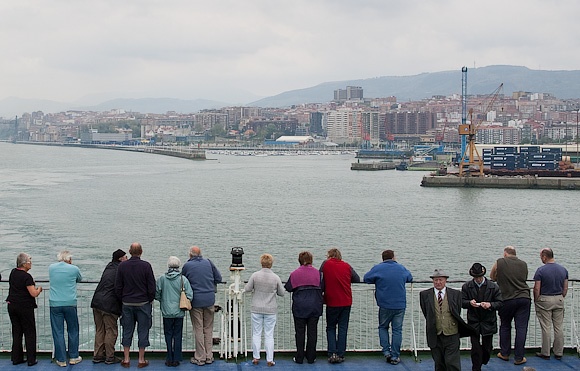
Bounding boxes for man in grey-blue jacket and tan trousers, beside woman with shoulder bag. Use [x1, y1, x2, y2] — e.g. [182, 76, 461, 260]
[181, 246, 222, 366]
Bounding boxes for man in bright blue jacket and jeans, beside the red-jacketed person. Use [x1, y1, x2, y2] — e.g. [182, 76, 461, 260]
[363, 250, 413, 365]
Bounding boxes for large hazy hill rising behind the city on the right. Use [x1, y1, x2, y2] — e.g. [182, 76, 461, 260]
[248, 66, 580, 107]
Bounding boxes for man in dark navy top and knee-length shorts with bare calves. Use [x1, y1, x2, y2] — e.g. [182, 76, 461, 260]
[115, 243, 155, 368]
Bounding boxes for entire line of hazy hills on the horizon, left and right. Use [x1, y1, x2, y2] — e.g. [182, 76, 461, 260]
[0, 66, 580, 118]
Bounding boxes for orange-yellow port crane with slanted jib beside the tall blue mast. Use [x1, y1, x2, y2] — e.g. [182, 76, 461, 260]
[459, 83, 503, 176]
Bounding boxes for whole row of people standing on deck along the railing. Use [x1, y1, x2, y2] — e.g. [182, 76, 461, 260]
[6, 243, 568, 370]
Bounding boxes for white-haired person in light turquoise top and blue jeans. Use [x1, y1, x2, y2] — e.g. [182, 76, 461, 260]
[48, 250, 83, 367]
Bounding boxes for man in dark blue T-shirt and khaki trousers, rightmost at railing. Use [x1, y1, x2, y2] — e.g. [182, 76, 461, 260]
[534, 248, 568, 359]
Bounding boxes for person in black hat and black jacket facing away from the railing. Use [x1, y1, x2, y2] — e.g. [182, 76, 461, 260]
[461, 263, 503, 371]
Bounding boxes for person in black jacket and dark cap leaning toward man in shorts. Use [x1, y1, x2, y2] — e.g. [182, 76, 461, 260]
[91, 249, 127, 365]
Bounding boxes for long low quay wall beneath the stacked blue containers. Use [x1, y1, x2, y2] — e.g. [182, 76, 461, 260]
[421, 175, 580, 190]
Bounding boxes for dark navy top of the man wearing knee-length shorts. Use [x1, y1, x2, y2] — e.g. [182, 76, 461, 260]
[115, 256, 155, 303]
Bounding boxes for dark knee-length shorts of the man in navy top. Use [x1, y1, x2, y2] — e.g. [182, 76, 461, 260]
[121, 303, 153, 349]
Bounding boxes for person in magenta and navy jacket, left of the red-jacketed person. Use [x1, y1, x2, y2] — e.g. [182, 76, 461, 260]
[284, 251, 323, 364]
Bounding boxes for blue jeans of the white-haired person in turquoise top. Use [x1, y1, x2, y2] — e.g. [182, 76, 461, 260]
[50, 306, 79, 362]
